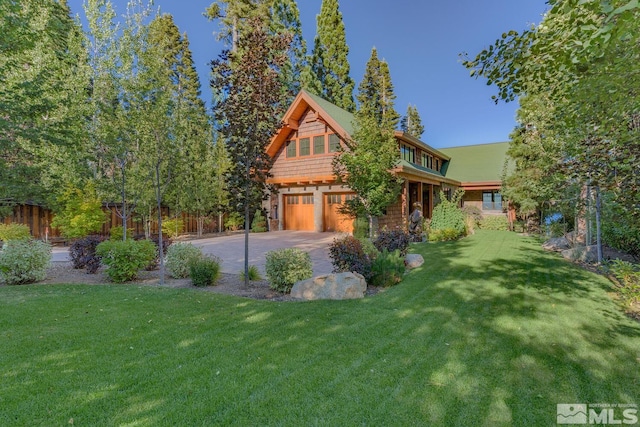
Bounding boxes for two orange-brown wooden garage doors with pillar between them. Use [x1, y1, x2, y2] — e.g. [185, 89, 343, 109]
[282, 192, 355, 232]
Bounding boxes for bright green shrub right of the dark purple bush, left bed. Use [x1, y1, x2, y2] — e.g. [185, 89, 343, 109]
[96, 239, 156, 283]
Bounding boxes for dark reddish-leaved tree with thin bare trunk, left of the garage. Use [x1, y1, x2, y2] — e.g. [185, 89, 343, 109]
[211, 18, 291, 281]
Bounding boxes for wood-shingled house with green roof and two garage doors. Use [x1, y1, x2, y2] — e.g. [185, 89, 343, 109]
[266, 90, 507, 232]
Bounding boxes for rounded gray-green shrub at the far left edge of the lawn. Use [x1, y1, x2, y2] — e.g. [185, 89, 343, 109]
[0, 240, 51, 285]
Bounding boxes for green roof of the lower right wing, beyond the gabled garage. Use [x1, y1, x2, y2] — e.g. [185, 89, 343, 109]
[439, 142, 509, 182]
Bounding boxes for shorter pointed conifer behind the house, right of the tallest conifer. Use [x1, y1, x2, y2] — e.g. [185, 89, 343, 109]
[357, 47, 400, 129]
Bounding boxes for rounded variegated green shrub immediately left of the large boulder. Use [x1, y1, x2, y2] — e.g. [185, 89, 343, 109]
[265, 248, 313, 292]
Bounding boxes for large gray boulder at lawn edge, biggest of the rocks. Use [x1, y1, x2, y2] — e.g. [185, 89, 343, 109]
[291, 272, 367, 300]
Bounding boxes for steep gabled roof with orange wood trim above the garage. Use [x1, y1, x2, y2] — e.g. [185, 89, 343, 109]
[267, 89, 353, 157]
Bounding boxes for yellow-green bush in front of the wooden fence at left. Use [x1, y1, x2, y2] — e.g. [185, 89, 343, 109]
[51, 181, 107, 238]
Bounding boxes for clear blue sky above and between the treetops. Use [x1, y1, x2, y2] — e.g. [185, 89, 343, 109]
[68, 0, 547, 148]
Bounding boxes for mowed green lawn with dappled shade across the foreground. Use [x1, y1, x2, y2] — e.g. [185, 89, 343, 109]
[0, 231, 640, 426]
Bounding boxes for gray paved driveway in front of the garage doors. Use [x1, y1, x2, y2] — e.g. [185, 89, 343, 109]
[51, 231, 342, 276]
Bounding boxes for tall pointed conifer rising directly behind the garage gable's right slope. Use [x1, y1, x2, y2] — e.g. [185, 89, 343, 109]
[303, 0, 356, 112]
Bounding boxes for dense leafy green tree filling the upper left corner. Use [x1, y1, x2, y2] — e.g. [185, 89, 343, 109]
[0, 0, 88, 216]
